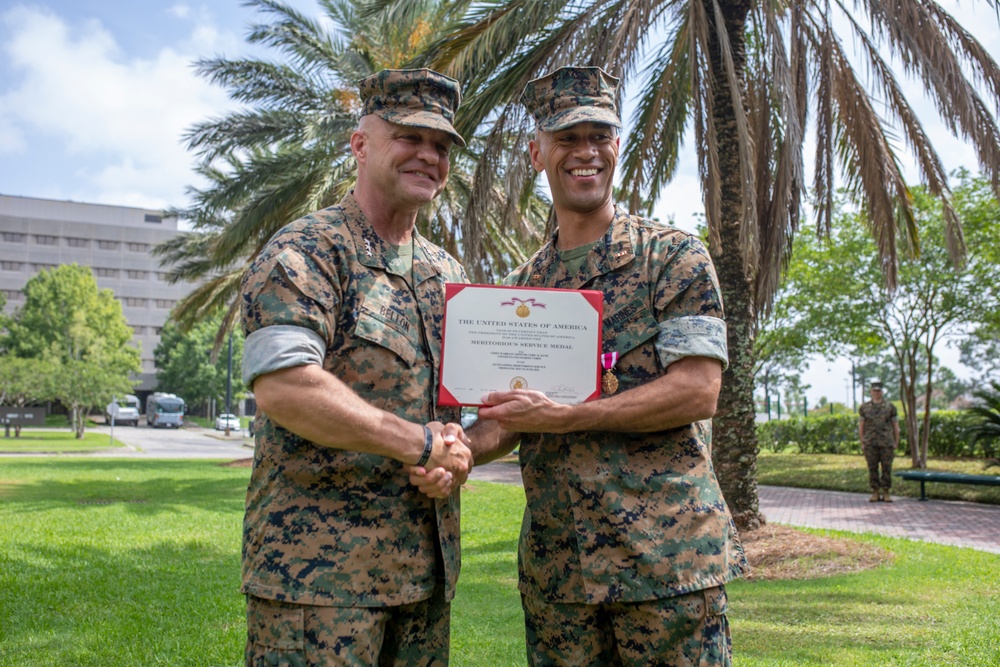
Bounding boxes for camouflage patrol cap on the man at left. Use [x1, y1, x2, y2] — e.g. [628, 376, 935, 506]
[358, 68, 465, 146]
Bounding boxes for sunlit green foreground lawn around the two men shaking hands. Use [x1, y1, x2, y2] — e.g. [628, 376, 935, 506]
[0, 457, 1000, 667]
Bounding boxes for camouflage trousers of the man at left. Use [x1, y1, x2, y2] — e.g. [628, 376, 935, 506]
[246, 586, 451, 667]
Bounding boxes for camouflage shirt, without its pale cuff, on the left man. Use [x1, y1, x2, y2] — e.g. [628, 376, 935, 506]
[242, 196, 465, 664]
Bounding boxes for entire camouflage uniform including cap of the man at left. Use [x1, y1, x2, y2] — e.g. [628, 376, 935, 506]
[242, 69, 466, 665]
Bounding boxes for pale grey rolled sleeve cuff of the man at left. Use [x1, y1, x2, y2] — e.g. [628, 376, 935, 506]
[243, 324, 326, 388]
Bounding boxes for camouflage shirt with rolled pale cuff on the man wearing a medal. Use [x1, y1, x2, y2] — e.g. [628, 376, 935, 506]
[506, 209, 747, 664]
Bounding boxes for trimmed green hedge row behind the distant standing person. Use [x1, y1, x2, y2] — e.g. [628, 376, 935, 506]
[757, 410, 1000, 458]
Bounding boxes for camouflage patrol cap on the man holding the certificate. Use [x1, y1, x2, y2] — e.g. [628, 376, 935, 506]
[521, 67, 622, 132]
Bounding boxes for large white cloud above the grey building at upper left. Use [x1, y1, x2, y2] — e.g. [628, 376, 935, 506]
[0, 7, 235, 206]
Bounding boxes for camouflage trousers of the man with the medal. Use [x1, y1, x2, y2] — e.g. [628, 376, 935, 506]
[521, 586, 732, 667]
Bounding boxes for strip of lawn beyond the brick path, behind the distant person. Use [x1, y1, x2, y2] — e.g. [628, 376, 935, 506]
[757, 450, 1000, 505]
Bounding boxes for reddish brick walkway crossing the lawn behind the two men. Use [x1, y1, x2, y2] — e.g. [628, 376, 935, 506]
[469, 462, 1000, 554]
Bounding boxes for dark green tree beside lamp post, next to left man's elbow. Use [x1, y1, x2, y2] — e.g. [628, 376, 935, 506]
[153, 316, 246, 414]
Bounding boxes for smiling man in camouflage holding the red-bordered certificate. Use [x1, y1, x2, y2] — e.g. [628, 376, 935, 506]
[473, 68, 747, 666]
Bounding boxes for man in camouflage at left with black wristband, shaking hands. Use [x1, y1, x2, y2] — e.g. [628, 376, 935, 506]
[242, 70, 470, 665]
